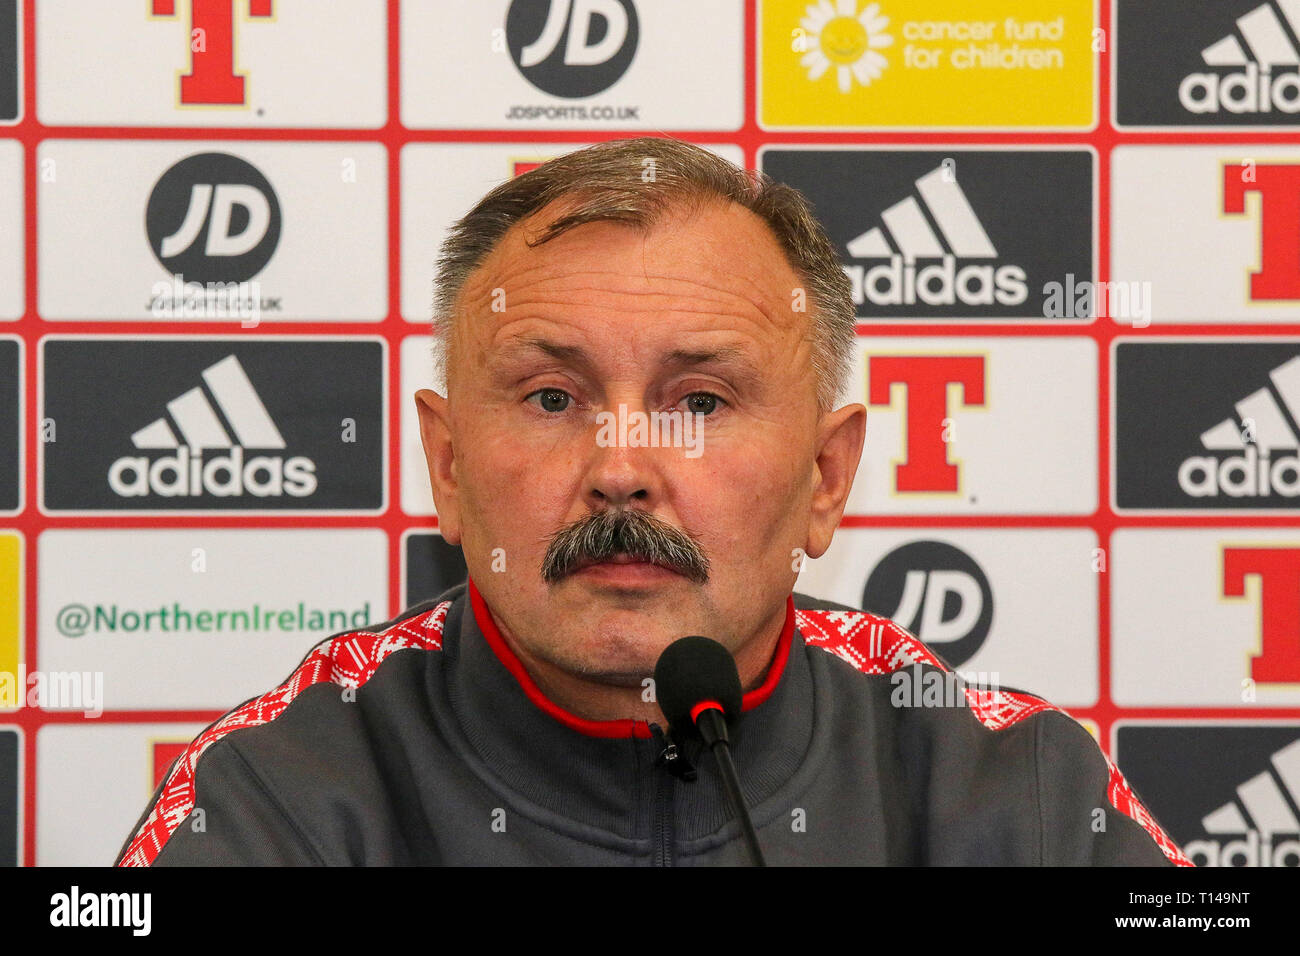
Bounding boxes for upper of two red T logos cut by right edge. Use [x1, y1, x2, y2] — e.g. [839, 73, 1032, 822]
[1223, 163, 1300, 299]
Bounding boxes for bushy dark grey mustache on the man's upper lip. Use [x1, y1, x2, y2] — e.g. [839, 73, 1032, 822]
[542, 510, 710, 584]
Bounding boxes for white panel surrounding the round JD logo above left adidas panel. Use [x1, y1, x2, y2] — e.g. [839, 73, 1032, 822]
[38, 139, 389, 321]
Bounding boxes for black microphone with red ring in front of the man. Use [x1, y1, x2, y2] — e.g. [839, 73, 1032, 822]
[654, 635, 767, 866]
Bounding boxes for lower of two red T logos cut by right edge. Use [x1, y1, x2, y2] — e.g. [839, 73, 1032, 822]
[1223, 548, 1300, 684]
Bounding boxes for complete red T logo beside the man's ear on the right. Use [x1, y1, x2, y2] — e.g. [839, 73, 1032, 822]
[867, 355, 984, 493]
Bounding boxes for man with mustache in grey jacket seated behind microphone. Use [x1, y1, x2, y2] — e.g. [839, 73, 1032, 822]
[120, 138, 1187, 865]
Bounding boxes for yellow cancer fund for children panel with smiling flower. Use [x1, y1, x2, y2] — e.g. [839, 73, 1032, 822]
[759, 0, 1106, 129]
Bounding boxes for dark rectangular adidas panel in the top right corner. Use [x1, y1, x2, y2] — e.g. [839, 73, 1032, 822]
[1115, 0, 1300, 126]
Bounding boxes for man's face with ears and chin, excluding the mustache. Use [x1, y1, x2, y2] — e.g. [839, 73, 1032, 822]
[420, 196, 865, 685]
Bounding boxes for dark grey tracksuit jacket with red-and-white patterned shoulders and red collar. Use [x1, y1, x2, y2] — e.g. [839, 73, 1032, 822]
[117, 574, 1187, 866]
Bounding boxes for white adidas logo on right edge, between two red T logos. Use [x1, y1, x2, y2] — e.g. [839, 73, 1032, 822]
[1178, 356, 1300, 498]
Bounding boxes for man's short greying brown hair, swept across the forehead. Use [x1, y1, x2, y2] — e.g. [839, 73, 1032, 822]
[433, 137, 857, 411]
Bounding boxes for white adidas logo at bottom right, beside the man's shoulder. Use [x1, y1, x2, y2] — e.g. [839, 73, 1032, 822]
[1183, 740, 1300, 866]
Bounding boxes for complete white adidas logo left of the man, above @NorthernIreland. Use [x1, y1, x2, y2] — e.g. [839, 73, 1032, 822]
[108, 355, 316, 498]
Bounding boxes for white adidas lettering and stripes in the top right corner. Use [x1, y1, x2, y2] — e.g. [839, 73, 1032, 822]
[1178, 0, 1300, 113]
